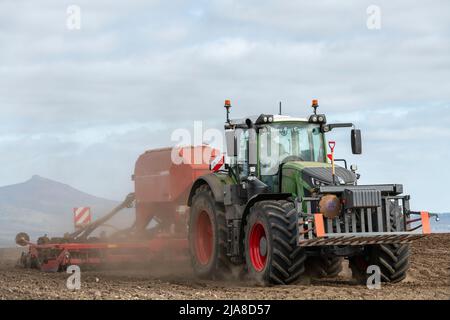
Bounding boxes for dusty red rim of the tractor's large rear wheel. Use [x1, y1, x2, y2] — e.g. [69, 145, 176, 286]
[195, 211, 213, 265]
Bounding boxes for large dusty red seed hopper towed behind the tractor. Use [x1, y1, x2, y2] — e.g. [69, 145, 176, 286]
[133, 146, 219, 231]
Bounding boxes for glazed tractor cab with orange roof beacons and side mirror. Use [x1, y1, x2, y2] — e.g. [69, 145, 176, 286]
[225, 100, 361, 195]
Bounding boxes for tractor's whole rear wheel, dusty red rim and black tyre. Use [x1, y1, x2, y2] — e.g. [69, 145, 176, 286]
[189, 186, 231, 278]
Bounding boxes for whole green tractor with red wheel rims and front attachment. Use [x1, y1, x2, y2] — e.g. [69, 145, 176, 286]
[188, 100, 430, 285]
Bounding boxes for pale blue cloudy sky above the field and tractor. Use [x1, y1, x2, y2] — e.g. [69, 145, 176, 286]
[0, 0, 450, 211]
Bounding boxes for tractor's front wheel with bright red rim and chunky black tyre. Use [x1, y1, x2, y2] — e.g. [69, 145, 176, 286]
[244, 201, 306, 285]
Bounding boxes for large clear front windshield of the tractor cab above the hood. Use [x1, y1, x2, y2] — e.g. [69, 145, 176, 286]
[259, 123, 325, 175]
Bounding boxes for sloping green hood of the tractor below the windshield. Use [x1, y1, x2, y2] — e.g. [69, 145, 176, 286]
[283, 161, 356, 187]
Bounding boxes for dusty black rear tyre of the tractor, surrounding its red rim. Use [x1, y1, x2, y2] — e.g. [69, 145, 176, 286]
[188, 185, 231, 278]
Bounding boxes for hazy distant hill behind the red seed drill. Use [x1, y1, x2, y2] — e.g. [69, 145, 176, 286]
[0, 175, 125, 246]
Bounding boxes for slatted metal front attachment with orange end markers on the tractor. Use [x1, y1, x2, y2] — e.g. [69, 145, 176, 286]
[298, 184, 430, 246]
